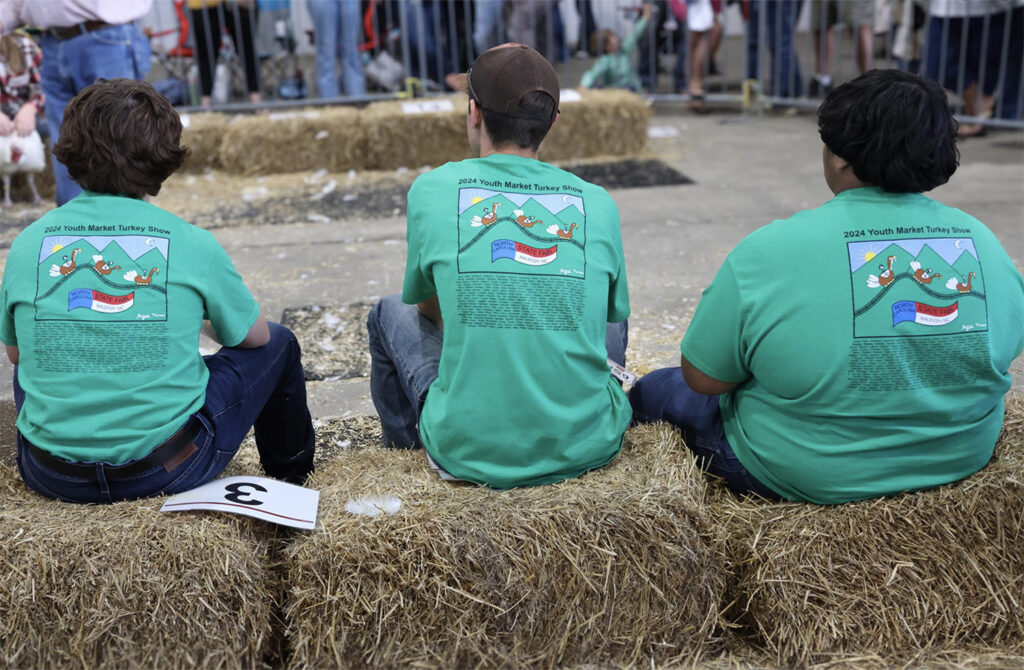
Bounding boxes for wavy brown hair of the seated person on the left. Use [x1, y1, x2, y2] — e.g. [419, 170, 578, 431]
[53, 79, 190, 198]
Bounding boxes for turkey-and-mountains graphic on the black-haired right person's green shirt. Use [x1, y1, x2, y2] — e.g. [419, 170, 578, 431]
[847, 238, 988, 337]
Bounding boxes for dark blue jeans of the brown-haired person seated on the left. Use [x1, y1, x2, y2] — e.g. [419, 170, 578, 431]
[14, 324, 313, 503]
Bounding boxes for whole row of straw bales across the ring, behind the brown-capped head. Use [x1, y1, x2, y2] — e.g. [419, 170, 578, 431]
[193, 90, 650, 175]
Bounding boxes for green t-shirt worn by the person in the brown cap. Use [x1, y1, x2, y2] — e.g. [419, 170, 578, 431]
[401, 154, 632, 488]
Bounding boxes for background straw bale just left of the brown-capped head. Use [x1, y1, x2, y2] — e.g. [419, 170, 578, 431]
[359, 94, 473, 170]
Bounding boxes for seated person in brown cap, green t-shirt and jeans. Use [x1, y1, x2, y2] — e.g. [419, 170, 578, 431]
[367, 44, 632, 489]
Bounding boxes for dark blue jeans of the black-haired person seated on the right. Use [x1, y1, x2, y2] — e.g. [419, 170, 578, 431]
[630, 368, 782, 500]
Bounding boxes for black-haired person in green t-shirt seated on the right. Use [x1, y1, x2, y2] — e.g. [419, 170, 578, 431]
[630, 70, 1024, 504]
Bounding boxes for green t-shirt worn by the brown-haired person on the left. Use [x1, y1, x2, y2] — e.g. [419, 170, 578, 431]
[0, 192, 259, 464]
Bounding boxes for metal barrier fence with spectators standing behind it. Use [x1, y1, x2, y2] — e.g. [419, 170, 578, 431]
[144, 0, 1024, 128]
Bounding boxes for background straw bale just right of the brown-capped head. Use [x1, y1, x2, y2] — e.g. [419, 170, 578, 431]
[540, 89, 650, 161]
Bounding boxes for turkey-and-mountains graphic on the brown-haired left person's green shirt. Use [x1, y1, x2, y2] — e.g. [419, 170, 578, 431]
[36, 235, 168, 323]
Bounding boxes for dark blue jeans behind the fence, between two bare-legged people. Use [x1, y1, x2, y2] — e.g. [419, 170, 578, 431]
[746, 0, 804, 97]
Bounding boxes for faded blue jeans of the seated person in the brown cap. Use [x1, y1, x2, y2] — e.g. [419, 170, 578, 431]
[367, 295, 628, 449]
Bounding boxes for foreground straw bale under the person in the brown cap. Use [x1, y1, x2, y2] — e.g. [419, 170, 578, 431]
[286, 423, 725, 668]
